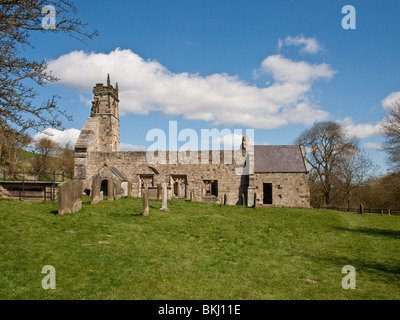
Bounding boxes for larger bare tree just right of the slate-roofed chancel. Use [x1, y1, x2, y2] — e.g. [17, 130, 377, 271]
[296, 121, 358, 206]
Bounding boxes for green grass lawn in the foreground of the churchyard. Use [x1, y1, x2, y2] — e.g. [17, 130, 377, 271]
[0, 197, 400, 300]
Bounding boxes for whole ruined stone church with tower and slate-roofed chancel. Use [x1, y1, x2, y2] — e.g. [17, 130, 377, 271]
[74, 76, 310, 207]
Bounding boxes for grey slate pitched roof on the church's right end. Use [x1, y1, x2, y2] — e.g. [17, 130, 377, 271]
[254, 145, 307, 173]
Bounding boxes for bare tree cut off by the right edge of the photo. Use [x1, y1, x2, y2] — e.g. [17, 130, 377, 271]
[382, 100, 400, 171]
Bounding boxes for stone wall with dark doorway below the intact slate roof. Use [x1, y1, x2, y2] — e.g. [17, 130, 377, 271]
[254, 173, 310, 208]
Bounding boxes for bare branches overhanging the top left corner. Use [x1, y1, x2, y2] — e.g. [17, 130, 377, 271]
[0, 0, 98, 134]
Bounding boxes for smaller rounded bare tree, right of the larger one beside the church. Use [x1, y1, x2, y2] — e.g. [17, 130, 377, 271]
[334, 150, 374, 210]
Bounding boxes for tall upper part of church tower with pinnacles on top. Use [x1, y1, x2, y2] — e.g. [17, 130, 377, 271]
[90, 74, 120, 152]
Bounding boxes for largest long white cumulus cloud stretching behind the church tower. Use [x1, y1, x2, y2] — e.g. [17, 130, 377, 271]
[49, 48, 335, 129]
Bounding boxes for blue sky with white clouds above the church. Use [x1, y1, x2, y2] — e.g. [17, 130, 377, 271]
[26, 0, 400, 171]
